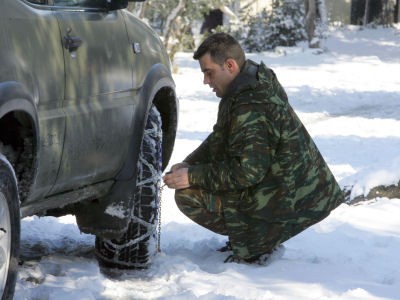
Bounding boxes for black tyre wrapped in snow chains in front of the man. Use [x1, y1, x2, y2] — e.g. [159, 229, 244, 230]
[95, 105, 162, 269]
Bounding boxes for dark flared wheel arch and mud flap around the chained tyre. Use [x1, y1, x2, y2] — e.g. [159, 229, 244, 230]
[75, 64, 178, 239]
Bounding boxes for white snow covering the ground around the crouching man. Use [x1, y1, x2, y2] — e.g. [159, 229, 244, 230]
[15, 26, 400, 300]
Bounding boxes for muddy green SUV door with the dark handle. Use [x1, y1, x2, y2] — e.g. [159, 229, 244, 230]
[52, 0, 134, 193]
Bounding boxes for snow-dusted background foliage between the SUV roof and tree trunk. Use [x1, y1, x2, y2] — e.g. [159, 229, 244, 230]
[130, 0, 306, 60]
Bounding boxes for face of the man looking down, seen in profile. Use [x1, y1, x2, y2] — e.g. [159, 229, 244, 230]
[199, 53, 238, 98]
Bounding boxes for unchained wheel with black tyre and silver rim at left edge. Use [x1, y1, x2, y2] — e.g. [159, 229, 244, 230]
[0, 154, 20, 300]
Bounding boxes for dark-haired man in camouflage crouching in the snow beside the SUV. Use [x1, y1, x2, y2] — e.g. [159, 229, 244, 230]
[164, 33, 343, 263]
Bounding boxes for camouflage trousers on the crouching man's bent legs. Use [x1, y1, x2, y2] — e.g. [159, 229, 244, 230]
[175, 188, 315, 259]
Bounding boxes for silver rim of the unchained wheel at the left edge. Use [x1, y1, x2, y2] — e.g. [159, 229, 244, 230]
[0, 192, 11, 296]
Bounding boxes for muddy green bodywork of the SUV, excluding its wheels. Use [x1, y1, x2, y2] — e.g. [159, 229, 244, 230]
[0, 0, 178, 231]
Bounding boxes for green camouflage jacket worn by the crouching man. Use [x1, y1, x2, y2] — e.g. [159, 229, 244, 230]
[185, 60, 343, 257]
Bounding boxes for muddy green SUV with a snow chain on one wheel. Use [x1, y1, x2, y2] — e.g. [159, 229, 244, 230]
[0, 0, 178, 299]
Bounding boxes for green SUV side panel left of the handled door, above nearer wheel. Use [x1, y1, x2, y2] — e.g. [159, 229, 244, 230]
[0, 0, 65, 201]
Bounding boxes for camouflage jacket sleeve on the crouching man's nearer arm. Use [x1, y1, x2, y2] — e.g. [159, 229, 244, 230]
[189, 103, 281, 191]
